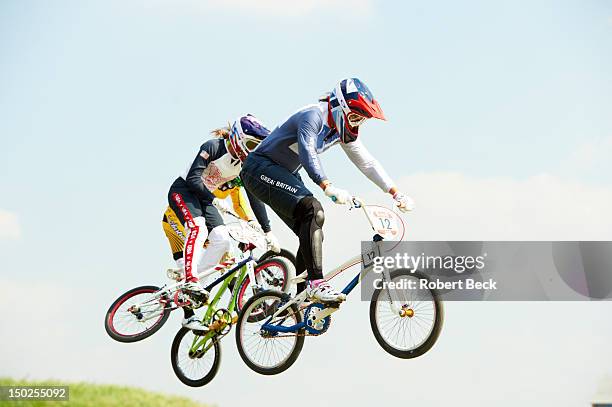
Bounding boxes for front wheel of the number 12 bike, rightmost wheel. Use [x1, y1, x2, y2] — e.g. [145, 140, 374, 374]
[370, 270, 444, 359]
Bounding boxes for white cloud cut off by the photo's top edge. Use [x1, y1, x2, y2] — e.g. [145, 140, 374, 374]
[204, 0, 372, 17]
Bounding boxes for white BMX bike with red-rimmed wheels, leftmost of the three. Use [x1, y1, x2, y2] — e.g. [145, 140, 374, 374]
[104, 215, 295, 343]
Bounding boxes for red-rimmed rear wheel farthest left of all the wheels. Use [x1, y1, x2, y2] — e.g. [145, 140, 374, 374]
[104, 285, 170, 343]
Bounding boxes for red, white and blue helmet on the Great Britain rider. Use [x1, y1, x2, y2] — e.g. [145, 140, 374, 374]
[329, 78, 386, 143]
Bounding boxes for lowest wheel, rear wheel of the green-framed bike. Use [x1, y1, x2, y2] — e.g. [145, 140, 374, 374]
[170, 328, 221, 387]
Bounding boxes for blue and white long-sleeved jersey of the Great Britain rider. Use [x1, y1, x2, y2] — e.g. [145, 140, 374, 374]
[257, 102, 393, 192]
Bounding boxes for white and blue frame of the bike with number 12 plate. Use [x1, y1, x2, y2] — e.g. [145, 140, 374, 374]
[261, 197, 400, 333]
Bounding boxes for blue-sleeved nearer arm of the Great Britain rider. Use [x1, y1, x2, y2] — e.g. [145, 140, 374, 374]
[297, 110, 327, 185]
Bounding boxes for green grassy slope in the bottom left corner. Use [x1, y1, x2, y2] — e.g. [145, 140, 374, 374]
[0, 378, 206, 407]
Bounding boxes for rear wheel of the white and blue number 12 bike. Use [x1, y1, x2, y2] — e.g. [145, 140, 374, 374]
[236, 291, 305, 375]
